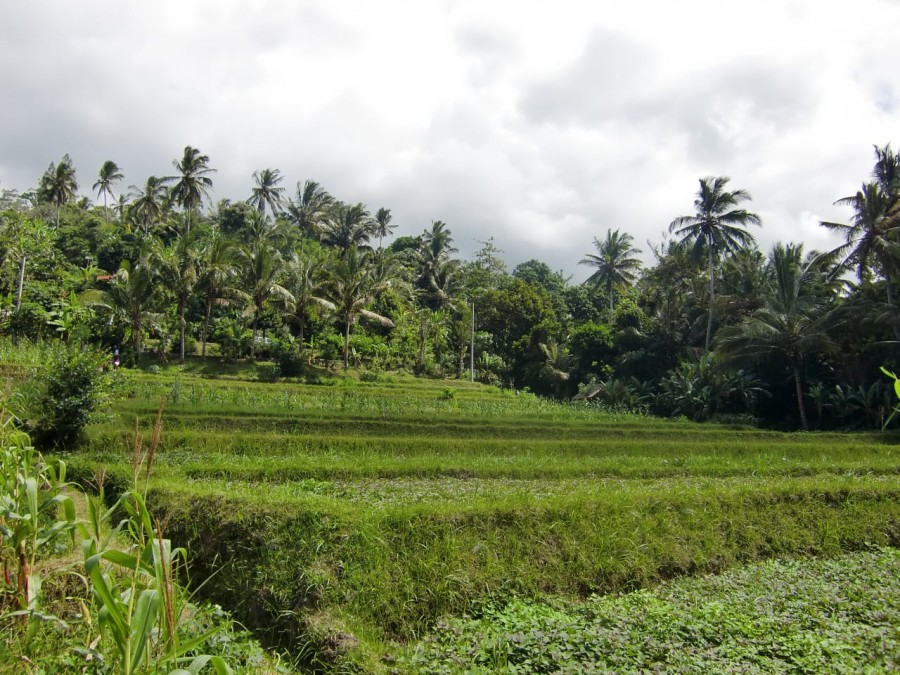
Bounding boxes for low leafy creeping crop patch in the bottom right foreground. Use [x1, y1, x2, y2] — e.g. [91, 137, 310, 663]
[400, 549, 900, 673]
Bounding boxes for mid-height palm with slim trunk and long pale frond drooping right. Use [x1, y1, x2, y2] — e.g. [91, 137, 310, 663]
[328, 246, 394, 368]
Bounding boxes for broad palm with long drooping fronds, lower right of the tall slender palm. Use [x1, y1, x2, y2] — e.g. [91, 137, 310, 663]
[716, 244, 836, 430]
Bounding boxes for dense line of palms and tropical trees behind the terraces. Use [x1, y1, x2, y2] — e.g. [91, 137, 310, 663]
[0, 145, 900, 429]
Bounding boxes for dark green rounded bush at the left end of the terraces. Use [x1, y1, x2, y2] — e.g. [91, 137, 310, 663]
[20, 344, 109, 448]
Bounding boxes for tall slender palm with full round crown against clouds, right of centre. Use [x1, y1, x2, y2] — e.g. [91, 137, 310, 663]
[669, 176, 761, 351]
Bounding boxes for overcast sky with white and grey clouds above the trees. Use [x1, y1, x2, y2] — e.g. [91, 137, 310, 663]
[0, 0, 900, 282]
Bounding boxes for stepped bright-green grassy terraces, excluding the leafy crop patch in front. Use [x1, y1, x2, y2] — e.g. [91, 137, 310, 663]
[69, 373, 900, 672]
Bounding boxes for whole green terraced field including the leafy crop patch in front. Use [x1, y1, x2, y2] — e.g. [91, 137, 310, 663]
[0, 352, 900, 673]
